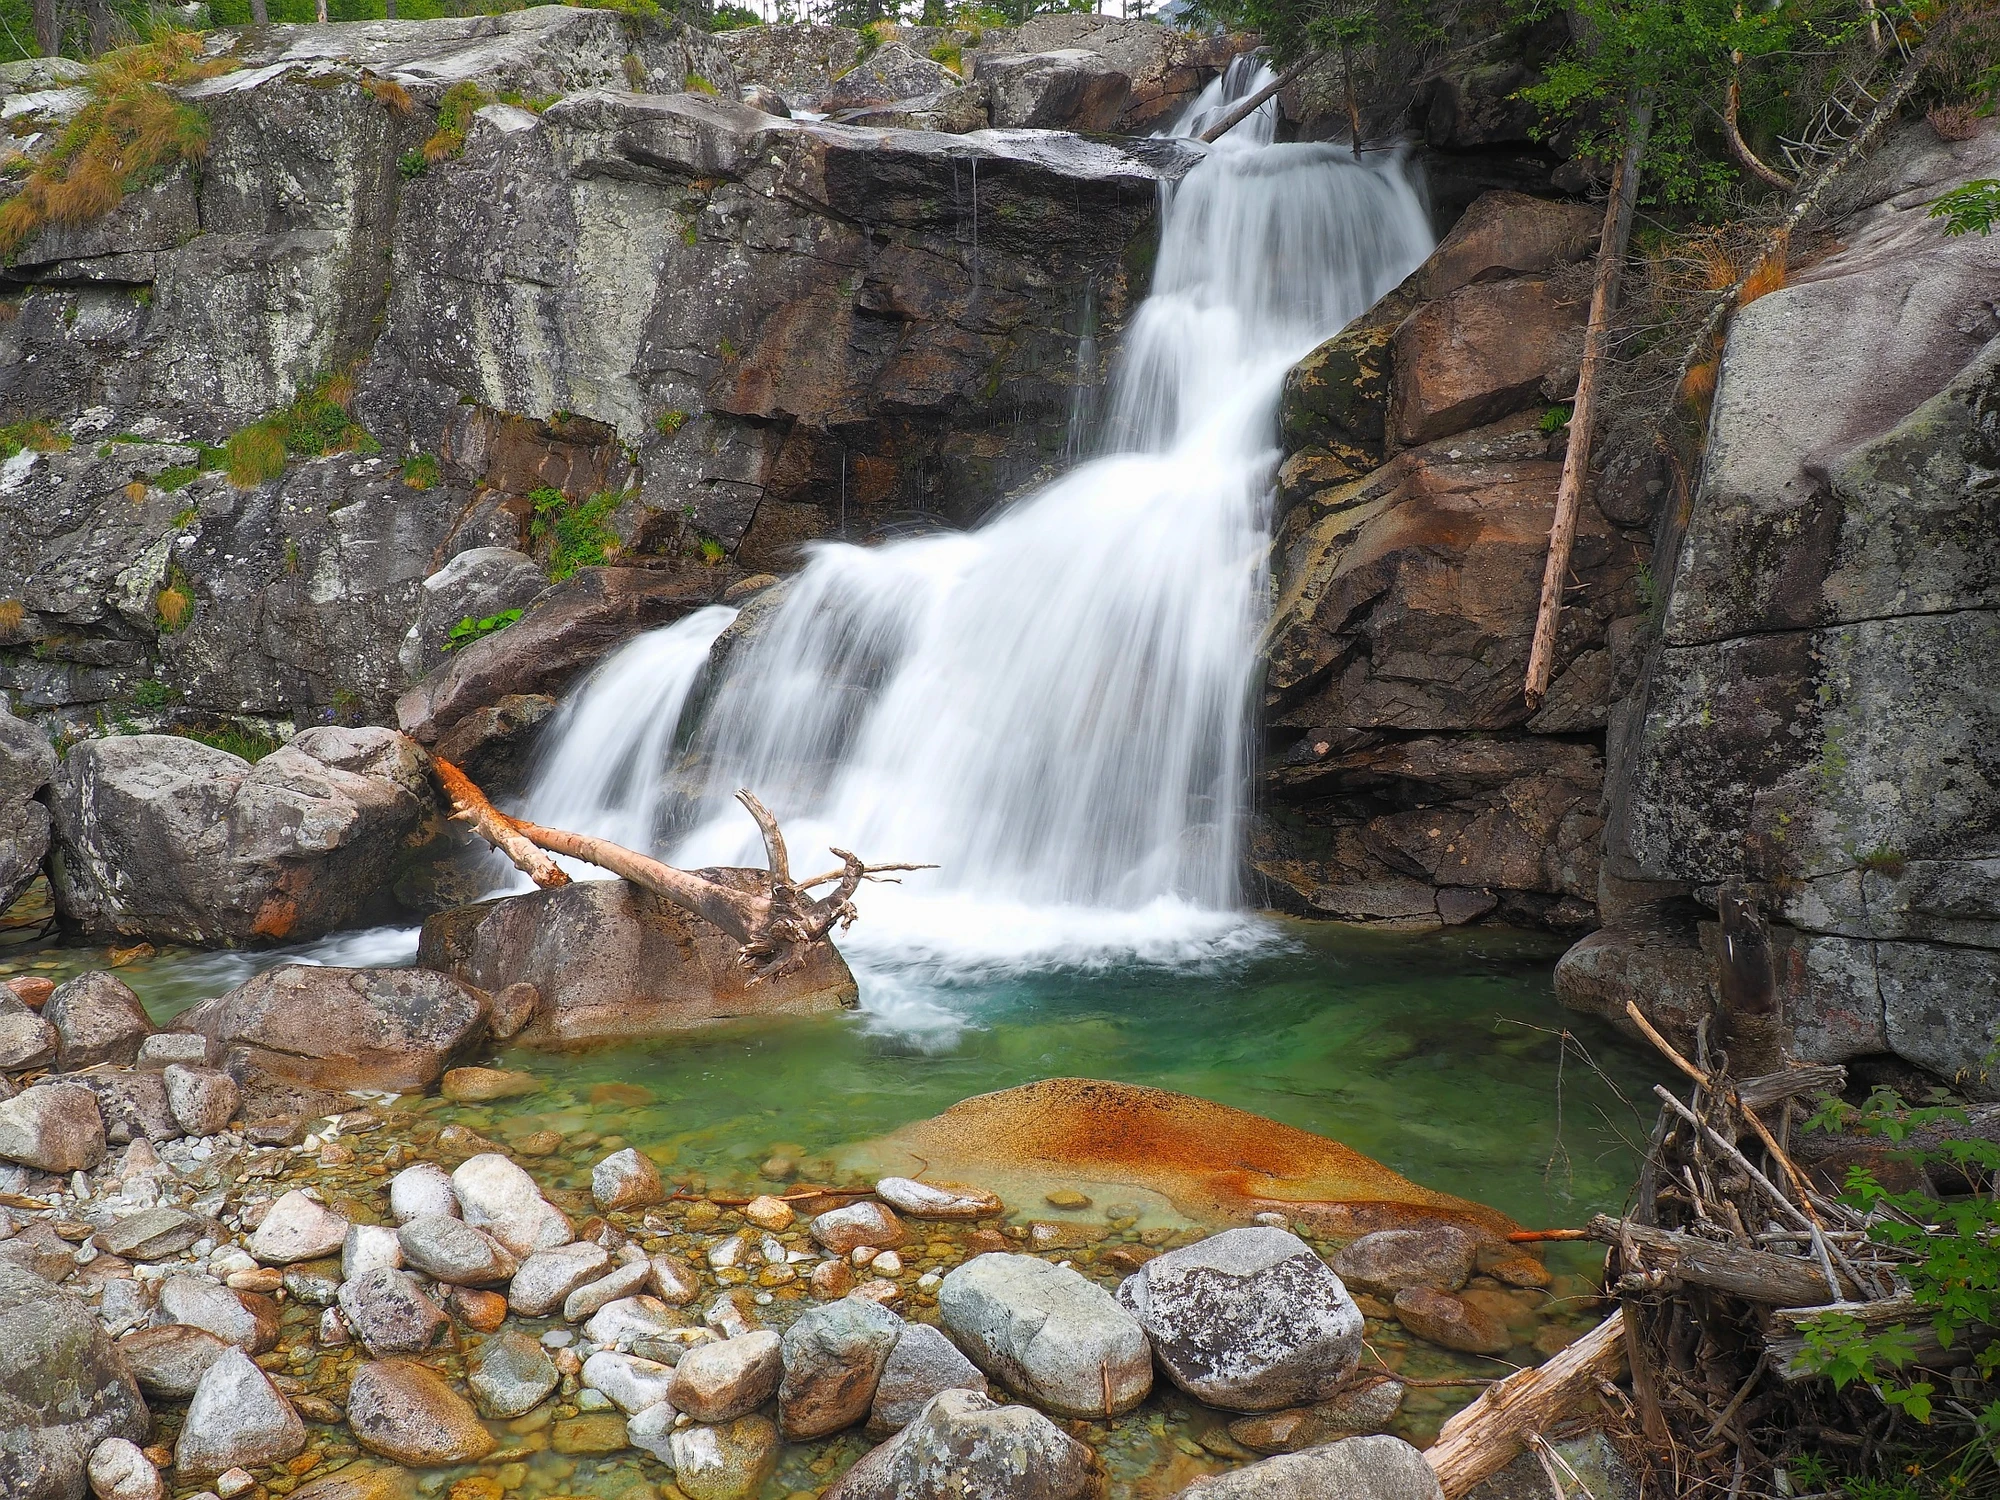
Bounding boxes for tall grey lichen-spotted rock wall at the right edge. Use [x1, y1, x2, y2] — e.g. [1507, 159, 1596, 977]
[1556, 126, 2000, 1096]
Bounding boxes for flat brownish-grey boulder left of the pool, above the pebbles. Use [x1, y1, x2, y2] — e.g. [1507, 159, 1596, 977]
[176, 964, 488, 1092]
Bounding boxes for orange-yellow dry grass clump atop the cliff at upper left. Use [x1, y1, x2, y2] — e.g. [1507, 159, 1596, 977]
[0, 30, 236, 256]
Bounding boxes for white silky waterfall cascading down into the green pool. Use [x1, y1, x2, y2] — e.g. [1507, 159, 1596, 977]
[526, 85, 1432, 976]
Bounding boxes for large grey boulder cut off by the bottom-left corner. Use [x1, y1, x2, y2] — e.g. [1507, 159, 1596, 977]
[0, 1262, 150, 1500]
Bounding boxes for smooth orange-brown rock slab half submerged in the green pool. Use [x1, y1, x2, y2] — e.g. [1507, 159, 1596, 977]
[846, 1078, 1514, 1236]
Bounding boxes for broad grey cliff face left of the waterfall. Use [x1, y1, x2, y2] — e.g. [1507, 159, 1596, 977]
[0, 6, 1196, 732]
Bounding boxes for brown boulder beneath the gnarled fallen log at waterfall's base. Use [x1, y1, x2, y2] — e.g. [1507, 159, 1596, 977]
[418, 870, 860, 1048]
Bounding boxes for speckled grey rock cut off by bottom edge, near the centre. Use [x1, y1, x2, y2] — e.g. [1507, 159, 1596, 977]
[826, 1390, 1092, 1500]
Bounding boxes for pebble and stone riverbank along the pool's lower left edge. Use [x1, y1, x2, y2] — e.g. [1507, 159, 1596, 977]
[0, 970, 1588, 1500]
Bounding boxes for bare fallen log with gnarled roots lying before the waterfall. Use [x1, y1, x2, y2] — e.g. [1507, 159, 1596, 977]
[432, 758, 936, 982]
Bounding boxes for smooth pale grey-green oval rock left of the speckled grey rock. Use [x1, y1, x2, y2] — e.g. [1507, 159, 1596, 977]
[938, 1254, 1152, 1418]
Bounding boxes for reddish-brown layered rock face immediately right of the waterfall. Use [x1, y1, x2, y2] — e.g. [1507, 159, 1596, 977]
[1252, 192, 1648, 930]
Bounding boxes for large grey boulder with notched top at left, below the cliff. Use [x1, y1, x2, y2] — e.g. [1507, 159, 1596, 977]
[54, 728, 434, 946]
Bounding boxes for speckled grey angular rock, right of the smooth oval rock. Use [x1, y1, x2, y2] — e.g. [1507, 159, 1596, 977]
[1118, 1226, 1362, 1412]
